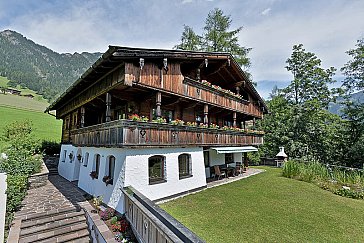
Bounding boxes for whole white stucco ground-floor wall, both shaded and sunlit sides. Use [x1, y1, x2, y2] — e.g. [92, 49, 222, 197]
[58, 145, 206, 213]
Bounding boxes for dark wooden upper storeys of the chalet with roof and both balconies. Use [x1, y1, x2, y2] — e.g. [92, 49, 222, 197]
[49, 47, 267, 147]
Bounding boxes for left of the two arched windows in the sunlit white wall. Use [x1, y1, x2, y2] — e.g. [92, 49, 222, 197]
[148, 155, 166, 184]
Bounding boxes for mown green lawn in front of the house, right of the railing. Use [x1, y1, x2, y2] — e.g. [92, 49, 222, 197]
[160, 167, 364, 242]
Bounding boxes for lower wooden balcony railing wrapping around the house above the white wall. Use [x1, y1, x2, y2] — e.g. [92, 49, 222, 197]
[70, 120, 263, 147]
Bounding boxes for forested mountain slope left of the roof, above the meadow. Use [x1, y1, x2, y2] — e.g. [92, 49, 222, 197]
[0, 30, 101, 100]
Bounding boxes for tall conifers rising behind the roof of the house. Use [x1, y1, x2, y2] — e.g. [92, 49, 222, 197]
[175, 8, 251, 68]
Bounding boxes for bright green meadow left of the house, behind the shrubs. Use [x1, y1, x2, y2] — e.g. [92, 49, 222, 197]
[0, 106, 62, 150]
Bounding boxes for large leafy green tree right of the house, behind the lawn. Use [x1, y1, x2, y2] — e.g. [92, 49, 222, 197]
[263, 44, 344, 163]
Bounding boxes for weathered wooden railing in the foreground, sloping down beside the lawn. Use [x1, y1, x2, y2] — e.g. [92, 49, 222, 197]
[121, 187, 204, 243]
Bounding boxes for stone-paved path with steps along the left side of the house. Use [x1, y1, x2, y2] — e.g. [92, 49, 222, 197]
[8, 175, 91, 243]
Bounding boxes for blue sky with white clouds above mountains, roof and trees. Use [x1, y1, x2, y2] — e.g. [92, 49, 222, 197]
[0, 0, 364, 97]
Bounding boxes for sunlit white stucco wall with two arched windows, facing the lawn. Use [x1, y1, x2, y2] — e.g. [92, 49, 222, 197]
[125, 148, 206, 200]
